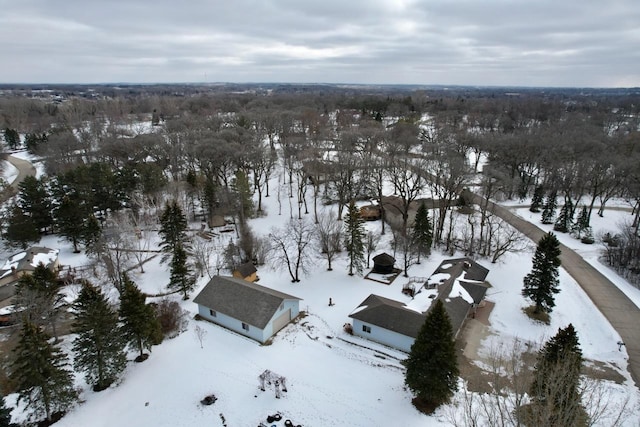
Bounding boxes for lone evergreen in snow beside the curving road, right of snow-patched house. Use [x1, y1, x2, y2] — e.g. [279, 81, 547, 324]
[522, 233, 560, 313]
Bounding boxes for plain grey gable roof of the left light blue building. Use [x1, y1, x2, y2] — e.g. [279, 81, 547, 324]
[193, 276, 300, 329]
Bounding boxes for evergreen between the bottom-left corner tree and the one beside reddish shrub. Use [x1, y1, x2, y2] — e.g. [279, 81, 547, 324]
[73, 283, 127, 391]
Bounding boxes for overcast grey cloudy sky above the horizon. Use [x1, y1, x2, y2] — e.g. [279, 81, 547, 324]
[0, 0, 640, 87]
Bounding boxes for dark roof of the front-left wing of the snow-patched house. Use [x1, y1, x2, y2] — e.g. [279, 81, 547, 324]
[349, 294, 425, 338]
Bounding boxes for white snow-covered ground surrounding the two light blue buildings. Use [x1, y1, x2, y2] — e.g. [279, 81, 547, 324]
[7, 180, 640, 427]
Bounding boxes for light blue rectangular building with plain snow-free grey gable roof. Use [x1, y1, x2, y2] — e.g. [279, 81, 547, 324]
[193, 276, 301, 344]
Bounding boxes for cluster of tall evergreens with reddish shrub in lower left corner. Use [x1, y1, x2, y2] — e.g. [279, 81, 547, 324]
[9, 264, 169, 422]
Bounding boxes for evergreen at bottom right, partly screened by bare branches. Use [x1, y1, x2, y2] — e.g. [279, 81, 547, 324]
[529, 324, 586, 426]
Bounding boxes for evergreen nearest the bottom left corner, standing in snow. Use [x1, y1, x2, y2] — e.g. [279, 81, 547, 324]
[10, 321, 78, 421]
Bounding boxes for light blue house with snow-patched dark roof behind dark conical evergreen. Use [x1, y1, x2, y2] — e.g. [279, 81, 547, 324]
[349, 258, 489, 352]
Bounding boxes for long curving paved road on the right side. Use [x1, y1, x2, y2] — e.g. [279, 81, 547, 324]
[467, 193, 640, 387]
